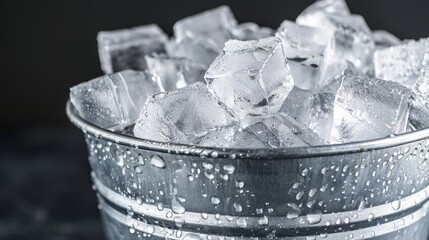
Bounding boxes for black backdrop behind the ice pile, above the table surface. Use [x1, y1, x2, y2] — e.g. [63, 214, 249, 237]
[0, 0, 429, 128]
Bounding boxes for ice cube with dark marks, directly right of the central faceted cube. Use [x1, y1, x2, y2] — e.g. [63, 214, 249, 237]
[276, 20, 332, 90]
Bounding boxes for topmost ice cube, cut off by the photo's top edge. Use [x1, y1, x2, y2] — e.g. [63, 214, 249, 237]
[296, 0, 350, 29]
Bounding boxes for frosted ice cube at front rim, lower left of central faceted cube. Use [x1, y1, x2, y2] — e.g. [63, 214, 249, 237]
[134, 82, 234, 144]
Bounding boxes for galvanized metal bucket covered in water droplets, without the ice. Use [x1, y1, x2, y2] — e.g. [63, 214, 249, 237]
[67, 103, 429, 240]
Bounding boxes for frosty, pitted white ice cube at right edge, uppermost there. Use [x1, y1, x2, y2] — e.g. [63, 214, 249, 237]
[374, 38, 429, 89]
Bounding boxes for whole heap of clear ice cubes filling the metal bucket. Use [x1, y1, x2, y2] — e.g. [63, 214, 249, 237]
[70, 0, 429, 148]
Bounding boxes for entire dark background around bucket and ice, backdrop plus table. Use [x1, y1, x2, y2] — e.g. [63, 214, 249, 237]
[0, 0, 429, 239]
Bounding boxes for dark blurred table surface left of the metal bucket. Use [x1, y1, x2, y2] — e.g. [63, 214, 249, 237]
[0, 126, 103, 240]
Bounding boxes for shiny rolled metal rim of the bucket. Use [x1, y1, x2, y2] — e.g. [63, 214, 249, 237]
[66, 100, 429, 160]
